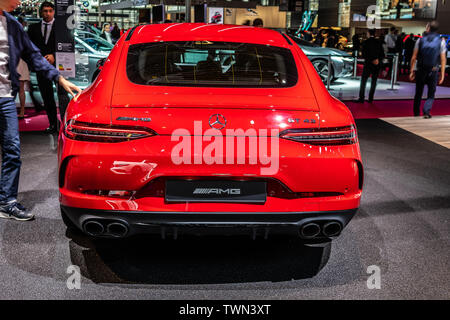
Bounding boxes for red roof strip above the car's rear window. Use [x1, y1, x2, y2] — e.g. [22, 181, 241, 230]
[130, 23, 289, 48]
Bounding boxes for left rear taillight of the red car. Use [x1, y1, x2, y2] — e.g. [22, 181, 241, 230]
[64, 120, 156, 143]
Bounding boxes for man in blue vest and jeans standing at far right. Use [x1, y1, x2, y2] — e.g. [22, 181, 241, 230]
[409, 21, 447, 119]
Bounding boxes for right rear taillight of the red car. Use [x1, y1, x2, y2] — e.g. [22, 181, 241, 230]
[280, 125, 357, 146]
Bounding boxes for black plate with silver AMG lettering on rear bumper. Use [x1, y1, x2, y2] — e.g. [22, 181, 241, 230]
[165, 180, 267, 203]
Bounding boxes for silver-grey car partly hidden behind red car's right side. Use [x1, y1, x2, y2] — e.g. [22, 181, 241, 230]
[292, 37, 354, 82]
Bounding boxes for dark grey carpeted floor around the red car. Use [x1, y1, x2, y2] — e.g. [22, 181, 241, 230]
[0, 119, 450, 300]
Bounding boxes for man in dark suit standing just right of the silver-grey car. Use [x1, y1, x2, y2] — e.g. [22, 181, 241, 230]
[356, 29, 384, 103]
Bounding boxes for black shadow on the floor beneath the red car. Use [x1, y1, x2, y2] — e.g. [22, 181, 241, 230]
[67, 231, 331, 284]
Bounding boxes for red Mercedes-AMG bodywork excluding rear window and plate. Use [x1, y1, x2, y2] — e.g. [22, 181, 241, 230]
[58, 23, 363, 239]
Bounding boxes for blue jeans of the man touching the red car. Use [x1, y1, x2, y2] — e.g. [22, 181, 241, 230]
[0, 98, 22, 203]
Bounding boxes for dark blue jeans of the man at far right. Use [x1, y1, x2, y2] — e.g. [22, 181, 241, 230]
[414, 70, 438, 116]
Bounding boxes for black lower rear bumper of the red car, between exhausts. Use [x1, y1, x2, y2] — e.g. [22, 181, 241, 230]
[61, 206, 357, 238]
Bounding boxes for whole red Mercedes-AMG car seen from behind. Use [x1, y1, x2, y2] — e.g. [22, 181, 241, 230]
[58, 23, 363, 241]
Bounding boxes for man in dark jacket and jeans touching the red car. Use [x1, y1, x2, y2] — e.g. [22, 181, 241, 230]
[0, 0, 81, 221]
